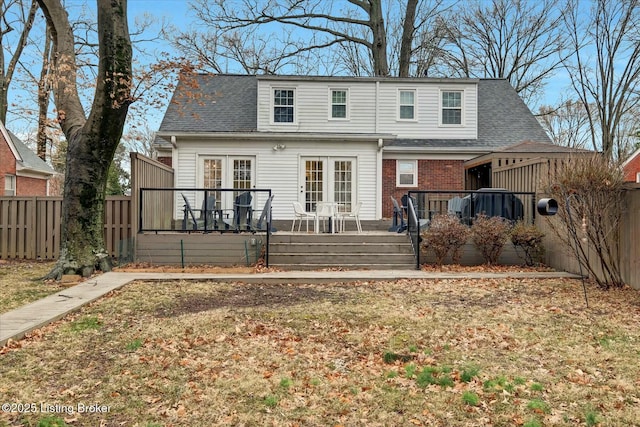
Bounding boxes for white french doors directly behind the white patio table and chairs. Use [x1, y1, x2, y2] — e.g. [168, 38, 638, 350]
[299, 156, 356, 212]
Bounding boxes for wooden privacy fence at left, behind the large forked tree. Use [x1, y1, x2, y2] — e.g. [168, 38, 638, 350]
[0, 196, 133, 259]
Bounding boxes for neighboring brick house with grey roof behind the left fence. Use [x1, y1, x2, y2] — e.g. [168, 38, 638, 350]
[0, 122, 56, 196]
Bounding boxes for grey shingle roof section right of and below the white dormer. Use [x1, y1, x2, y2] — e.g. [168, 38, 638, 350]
[385, 79, 551, 151]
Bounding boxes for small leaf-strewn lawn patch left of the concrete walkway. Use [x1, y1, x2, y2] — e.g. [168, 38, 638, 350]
[0, 260, 66, 314]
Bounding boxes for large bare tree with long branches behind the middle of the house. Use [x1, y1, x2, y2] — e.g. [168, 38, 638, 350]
[175, 0, 443, 76]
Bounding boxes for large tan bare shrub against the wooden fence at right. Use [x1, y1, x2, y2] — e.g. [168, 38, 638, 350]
[542, 154, 624, 289]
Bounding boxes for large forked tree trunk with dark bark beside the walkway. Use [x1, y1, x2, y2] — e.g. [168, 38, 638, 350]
[38, 0, 132, 278]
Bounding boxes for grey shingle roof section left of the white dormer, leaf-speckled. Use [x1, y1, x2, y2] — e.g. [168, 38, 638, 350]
[160, 74, 258, 132]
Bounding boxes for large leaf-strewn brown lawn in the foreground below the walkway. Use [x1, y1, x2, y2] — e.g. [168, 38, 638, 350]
[0, 279, 640, 427]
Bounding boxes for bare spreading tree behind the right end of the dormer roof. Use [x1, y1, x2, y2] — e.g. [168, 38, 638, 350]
[439, 0, 566, 101]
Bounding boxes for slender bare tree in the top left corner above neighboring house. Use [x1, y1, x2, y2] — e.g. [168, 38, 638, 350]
[0, 0, 38, 122]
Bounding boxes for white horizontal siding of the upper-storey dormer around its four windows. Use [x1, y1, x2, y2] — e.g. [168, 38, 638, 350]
[257, 77, 478, 139]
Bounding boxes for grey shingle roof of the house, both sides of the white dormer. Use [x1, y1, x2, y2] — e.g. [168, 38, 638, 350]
[156, 74, 551, 151]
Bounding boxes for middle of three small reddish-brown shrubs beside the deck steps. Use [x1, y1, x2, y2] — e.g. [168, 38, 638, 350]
[471, 214, 511, 265]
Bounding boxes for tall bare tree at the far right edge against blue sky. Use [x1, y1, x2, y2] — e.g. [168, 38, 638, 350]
[564, 0, 640, 158]
